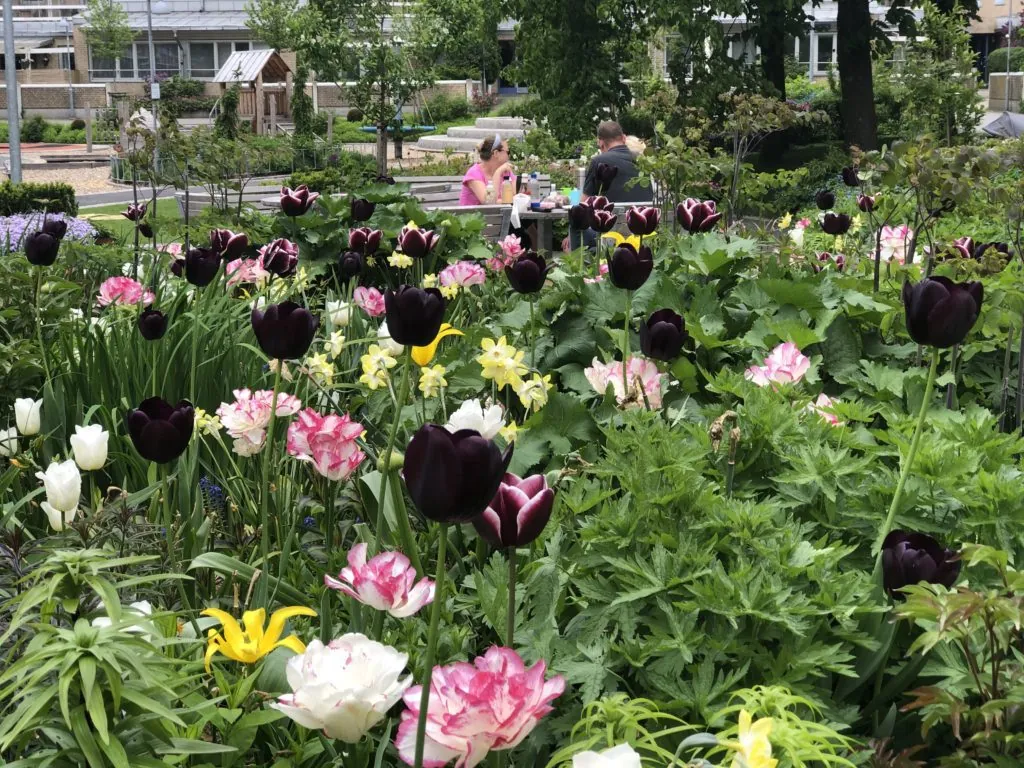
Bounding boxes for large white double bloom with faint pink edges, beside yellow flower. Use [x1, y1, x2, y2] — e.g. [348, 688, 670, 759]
[270, 633, 413, 744]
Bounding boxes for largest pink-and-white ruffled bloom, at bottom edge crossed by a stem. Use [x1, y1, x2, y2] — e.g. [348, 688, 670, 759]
[395, 646, 565, 768]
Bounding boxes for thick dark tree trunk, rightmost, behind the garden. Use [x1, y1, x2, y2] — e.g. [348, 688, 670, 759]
[836, 0, 879, 151]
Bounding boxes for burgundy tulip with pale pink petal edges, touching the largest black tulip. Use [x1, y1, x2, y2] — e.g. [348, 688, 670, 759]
[473, 472, 555, 548]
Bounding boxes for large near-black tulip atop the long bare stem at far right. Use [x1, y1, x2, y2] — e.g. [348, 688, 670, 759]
[903, 276, 983, 349]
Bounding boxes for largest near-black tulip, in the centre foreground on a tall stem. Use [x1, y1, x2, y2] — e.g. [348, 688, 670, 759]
[399, 423, 512, 522]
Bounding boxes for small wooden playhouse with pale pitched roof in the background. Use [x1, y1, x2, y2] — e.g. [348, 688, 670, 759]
[213, 48, 292, 134]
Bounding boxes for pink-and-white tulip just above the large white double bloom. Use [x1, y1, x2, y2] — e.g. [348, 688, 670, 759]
[324, 544, 434, 618]
